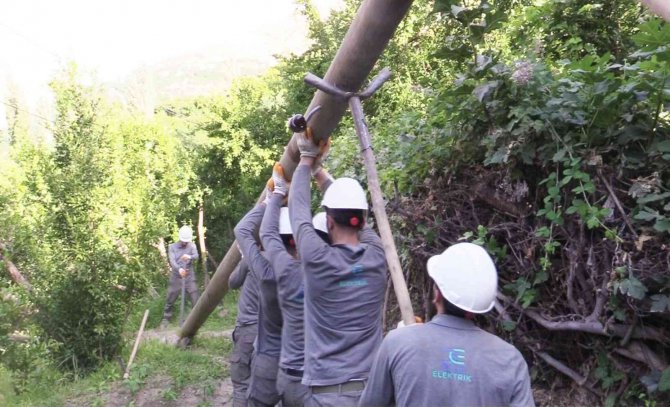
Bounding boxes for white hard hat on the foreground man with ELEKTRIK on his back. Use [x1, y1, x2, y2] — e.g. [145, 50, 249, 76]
[426, 243, 498, 314]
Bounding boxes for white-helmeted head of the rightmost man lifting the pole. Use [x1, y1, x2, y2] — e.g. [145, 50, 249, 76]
[321, 177, 368, 229]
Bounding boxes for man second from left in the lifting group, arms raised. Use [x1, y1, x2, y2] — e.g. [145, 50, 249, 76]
[235, 198, 282, 406]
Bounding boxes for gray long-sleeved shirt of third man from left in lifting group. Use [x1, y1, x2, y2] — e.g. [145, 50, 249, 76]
[260, 194, 305, 370]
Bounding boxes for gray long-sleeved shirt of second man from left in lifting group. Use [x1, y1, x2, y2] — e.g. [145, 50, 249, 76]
[235, 204, 282, 358]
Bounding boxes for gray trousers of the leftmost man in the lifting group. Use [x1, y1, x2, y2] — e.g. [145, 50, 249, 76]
[230, 324, 258, 407]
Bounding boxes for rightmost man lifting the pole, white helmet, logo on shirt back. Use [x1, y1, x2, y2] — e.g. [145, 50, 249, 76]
[289, 132, 388, 407]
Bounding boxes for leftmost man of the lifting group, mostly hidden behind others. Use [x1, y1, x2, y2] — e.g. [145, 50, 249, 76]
[228, 259, 259, 407]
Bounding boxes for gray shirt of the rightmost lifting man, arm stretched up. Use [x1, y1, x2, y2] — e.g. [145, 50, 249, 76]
[289, 165, 387, 386]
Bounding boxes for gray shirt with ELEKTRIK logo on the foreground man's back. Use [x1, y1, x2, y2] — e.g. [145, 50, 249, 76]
[359, 314, 535, 407]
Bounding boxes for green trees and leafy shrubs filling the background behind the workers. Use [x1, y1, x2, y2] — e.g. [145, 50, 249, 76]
[0, 0, 670, 403]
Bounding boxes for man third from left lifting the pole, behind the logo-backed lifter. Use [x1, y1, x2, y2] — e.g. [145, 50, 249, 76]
[260, 163, 308, 407]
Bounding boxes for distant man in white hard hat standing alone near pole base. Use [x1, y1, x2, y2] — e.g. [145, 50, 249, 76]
[161, 225, 200, 327]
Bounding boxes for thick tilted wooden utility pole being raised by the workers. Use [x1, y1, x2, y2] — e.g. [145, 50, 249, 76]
[180, 0, 412, 341]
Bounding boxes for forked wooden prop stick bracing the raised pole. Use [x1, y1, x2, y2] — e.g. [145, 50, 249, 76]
[305, 68, 415, 325]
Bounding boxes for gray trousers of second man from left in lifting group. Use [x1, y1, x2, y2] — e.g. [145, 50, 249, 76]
[248, 353, 279, 407]
